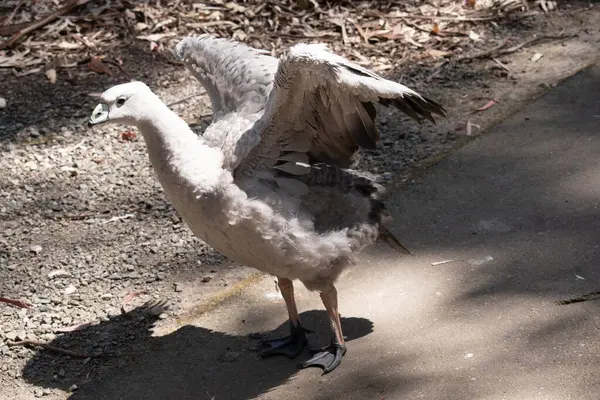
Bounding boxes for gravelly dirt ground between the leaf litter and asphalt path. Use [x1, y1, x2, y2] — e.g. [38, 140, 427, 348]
[0, 1, 600, 399]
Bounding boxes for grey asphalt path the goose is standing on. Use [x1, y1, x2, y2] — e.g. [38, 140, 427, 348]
[59, 67, 600, 400]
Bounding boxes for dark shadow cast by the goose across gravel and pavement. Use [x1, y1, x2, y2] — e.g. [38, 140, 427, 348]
[22, 310, 373, 400]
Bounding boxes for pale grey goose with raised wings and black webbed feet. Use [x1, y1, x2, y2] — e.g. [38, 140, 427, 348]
[88, 37, 445, 374]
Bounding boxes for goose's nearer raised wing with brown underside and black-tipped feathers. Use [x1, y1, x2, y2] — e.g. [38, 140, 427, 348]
[236, 44, 445, 180]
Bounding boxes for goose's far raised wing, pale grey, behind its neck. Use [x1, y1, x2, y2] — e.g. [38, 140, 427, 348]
[175, 36, 278, 121]
